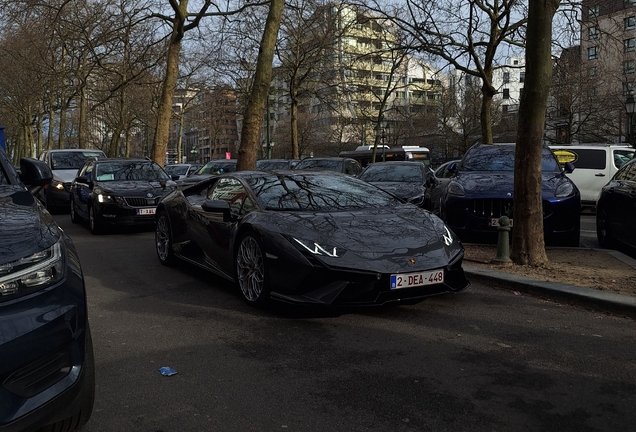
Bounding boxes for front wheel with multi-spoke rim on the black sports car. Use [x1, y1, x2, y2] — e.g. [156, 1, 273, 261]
[234, 233, 269, 306]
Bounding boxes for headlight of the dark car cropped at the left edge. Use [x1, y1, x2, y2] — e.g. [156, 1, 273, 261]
[0, 239, 66, 297]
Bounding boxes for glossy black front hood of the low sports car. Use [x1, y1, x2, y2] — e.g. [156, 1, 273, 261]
[258, 205, 462, 273]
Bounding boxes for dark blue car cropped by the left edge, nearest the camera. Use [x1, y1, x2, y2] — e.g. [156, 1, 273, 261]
[0, 147, 95, 432]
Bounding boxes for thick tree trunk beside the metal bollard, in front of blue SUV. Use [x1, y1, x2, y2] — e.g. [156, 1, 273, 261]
[511, 0, 560, 266]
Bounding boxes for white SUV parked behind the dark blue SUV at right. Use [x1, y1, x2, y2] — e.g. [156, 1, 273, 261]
[550, 144, 634, 207]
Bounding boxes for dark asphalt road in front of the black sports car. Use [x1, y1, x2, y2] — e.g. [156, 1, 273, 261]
[56, 215, 636, 432]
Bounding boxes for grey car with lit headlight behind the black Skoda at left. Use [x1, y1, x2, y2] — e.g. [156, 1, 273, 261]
[38, 149, 106, 211]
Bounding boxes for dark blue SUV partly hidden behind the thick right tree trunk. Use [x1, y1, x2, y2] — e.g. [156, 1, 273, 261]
[440, 144, 581, 246]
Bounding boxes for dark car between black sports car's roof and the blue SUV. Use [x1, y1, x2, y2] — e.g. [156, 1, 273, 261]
[358, 161, 435, 208]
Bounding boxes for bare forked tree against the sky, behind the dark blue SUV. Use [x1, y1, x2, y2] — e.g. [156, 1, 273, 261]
[360, 0, 527, 143]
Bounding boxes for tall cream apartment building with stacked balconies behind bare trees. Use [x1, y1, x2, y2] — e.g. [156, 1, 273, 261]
[270, 4, 443, 156]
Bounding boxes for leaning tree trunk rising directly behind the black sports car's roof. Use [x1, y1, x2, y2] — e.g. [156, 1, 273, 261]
[236, 0, 285, 171]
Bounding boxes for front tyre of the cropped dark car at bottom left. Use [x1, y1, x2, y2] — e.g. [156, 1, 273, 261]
[38, 326, 95, 432]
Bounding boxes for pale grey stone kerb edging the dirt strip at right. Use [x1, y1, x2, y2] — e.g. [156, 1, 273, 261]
[463, 249, 636, 318]
